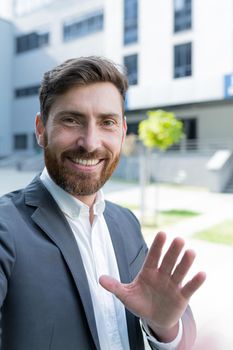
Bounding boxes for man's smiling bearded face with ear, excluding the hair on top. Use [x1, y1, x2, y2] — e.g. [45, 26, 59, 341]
[36, 82, 126, 209]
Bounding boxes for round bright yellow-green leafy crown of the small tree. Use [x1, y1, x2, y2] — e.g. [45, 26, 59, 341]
[138, 110, 183, 151]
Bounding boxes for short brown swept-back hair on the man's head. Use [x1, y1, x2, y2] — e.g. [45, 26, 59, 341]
[39, 56, 128, 124]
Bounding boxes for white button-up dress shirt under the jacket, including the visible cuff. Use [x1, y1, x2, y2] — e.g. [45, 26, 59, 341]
[40, 169, 182, 350]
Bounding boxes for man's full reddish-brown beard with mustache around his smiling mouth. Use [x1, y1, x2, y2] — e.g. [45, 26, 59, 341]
[44, 135, 120, 196]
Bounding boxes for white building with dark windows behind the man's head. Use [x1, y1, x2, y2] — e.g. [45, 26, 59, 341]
[0, 0, 233, 189]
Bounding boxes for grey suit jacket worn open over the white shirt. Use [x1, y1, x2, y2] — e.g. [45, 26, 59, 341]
[0, 177, 195, 350]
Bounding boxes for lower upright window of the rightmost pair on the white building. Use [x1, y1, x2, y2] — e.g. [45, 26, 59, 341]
[174, 43, 192, 78]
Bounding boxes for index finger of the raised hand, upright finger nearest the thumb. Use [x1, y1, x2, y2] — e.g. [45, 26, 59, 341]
[143, 232, 166, 269]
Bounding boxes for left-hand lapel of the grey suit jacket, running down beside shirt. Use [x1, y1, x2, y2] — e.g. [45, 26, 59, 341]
[25, 178, 100, 350]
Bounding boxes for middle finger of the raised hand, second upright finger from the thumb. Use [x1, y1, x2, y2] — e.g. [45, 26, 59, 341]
[159, 237, 184, 274]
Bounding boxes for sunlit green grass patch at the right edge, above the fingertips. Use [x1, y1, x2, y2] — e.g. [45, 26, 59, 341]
[193, 220, 233, 245]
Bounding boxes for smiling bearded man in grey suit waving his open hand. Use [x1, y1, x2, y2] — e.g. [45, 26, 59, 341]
[0, 57, 205, 350]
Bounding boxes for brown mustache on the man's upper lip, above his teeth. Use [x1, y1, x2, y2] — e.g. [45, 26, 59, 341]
[61, 146, 111, 160]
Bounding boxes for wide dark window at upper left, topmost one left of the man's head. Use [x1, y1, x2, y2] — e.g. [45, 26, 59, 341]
[16, 32, 49, 53]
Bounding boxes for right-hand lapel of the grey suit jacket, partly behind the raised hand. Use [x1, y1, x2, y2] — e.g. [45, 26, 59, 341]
[104, 205, 138, 349]
